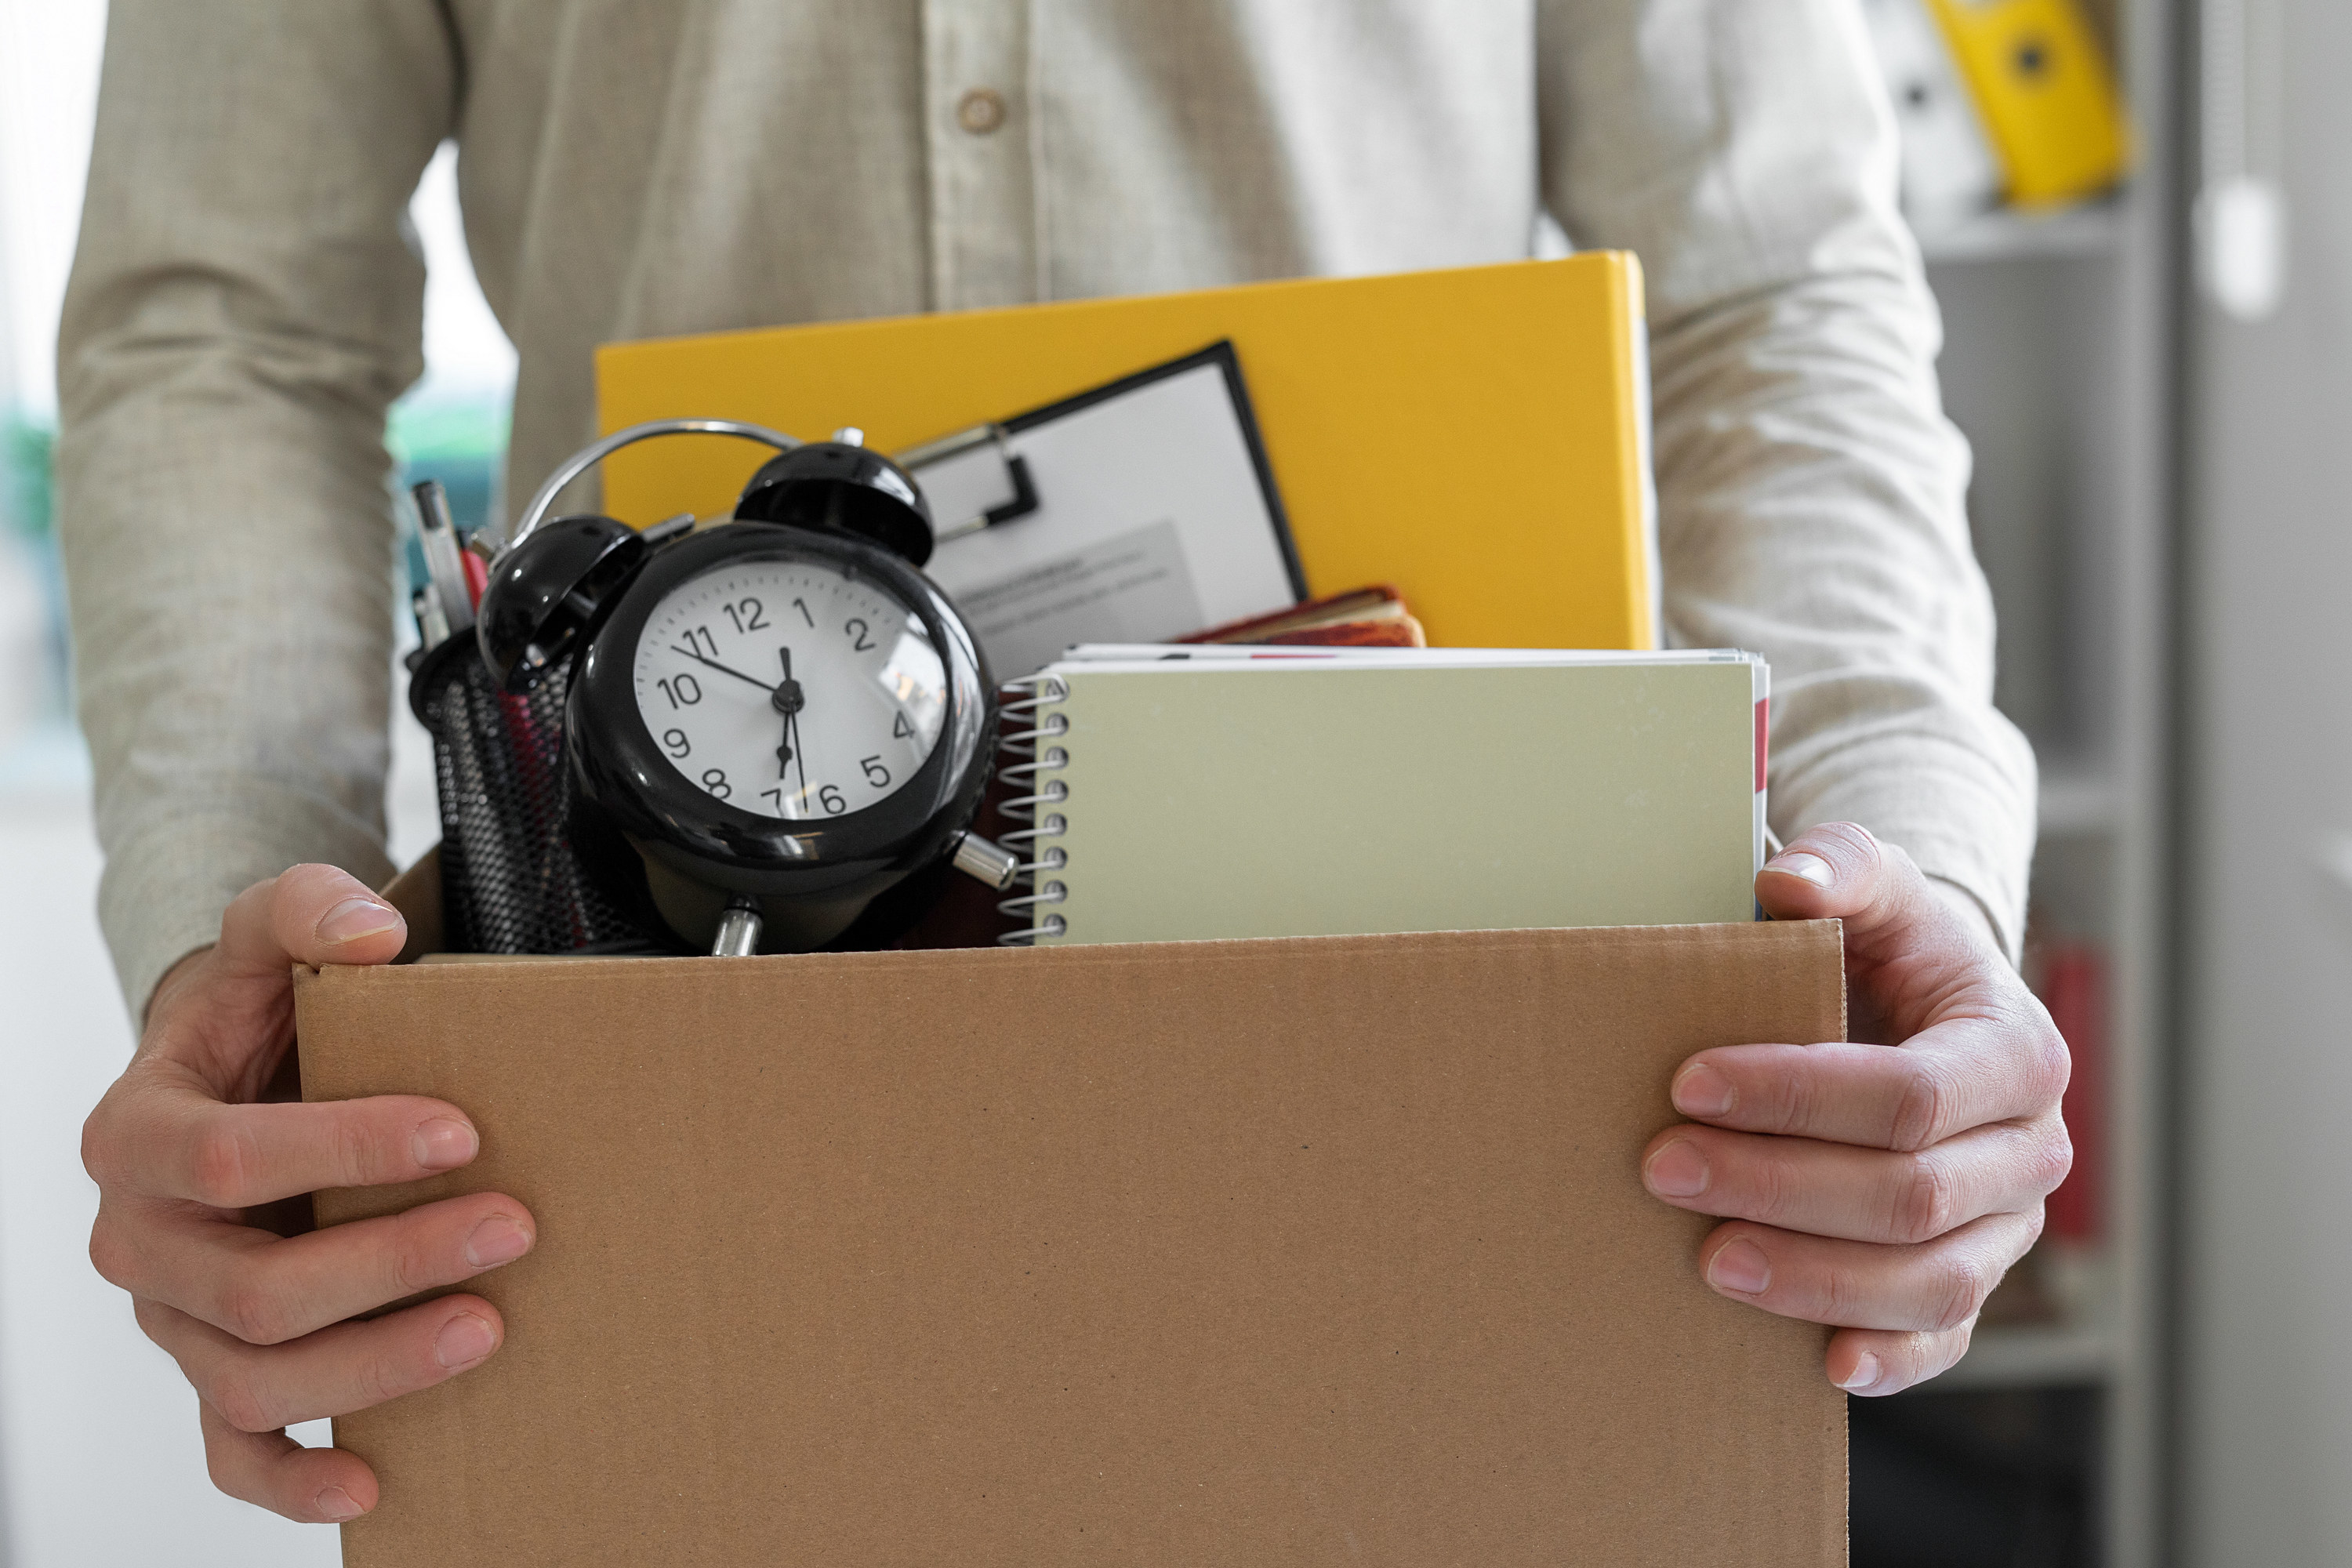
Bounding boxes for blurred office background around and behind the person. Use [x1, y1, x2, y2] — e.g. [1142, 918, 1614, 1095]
[0, 0, 2352, 1568]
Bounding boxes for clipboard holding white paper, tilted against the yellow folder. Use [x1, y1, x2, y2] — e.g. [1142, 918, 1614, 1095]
[906, 343, 1305, 680]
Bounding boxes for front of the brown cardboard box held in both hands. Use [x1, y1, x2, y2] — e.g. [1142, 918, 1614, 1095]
[296, 921, 1846, 1568]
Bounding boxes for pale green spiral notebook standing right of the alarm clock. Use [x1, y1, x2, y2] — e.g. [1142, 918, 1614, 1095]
[1007, 647, 1769, 945]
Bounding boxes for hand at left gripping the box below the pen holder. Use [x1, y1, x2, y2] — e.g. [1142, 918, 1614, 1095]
[82, 865, 534, 1523]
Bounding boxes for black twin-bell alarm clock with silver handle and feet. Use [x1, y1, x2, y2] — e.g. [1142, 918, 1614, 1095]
[480, 421, 1014, 954]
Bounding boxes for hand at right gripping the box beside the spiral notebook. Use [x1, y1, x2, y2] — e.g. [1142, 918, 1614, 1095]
[1642, 822, 2072, 1394]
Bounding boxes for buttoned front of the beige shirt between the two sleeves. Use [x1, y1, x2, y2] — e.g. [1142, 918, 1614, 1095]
[454, 0, 1541, 505]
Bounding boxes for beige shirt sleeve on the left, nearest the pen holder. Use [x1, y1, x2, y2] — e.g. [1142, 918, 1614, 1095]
[56, 0, 459, 1013]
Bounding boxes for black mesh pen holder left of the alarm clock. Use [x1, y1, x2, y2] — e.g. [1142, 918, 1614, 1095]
[409, 633, 656, 954]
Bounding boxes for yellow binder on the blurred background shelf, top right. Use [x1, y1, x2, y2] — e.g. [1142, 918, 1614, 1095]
[1929, 0, 2131, 207]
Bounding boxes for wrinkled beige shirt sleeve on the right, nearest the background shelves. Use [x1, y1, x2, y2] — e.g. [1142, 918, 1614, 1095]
[1538, 0, 2034, 956]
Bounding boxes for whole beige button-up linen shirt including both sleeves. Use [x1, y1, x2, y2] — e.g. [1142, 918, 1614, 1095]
[59, 0, 2034, 1006]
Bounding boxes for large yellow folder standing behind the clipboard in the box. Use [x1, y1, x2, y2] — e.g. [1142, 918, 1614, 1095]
[597, 252, 1658, 649]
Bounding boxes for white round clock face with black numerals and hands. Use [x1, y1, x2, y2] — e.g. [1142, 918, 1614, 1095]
[633, 560, 948, 820]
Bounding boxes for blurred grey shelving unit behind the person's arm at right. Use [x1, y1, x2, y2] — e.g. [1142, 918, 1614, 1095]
[1856, 0, 2183, 1568]
